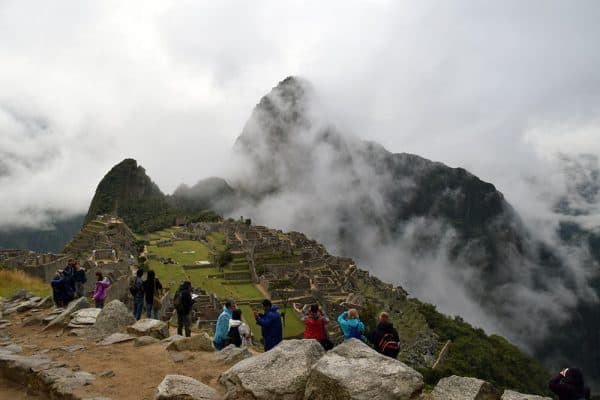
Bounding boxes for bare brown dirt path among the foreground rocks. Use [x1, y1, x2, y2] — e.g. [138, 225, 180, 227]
[0, 316, 230, 400]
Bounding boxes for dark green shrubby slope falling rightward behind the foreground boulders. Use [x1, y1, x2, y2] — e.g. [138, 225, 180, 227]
[411, 300, 550, 395]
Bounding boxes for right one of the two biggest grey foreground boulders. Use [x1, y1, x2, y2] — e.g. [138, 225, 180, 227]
[305, 339, 424, 400]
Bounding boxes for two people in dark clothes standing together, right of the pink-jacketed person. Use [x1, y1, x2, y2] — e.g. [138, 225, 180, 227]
[129, 268, 164, 321]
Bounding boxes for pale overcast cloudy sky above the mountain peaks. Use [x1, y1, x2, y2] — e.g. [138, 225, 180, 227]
[0, 0, 600, 227]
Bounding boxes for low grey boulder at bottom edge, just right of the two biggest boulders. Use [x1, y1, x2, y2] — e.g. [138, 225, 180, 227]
[431, 375, 500, 400]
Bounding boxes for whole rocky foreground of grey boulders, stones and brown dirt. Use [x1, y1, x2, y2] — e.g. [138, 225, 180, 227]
[0, 293, 542, 400]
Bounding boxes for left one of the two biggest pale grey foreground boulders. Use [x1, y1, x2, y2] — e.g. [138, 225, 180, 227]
[219, 340, 324, 400]
